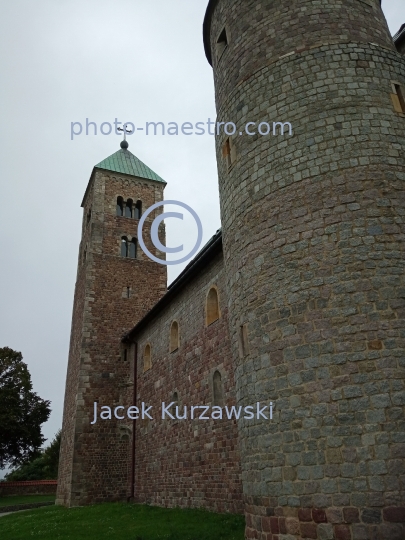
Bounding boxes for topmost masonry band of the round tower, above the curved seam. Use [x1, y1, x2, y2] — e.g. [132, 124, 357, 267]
[210, 0, 395, 113]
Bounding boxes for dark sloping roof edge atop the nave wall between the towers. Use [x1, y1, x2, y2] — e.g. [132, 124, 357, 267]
[122, 229, 222, 342]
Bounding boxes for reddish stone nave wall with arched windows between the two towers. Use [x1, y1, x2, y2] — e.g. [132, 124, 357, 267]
[135, 253, 243, 513]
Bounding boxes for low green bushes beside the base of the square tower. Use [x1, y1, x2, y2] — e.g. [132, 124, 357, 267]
[5, 430, 62, 482]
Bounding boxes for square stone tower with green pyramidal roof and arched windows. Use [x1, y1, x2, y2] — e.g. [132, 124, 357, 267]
[56, 141, 166, 506]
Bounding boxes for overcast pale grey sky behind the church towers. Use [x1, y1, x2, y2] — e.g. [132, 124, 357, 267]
[0, 0, 405, 472]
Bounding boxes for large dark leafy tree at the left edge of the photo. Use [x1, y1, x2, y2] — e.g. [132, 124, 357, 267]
[0, 347, 51, 468]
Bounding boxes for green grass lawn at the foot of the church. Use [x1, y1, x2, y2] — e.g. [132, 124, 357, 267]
[0, 503, 245, 540]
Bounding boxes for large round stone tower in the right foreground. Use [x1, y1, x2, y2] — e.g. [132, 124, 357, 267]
[204, 0, 405, 540]
